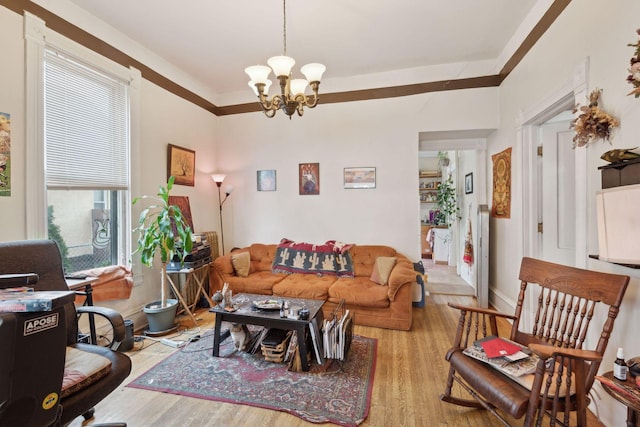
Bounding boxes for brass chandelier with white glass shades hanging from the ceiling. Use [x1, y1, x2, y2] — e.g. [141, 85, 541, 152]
[244, 0, 326, 119]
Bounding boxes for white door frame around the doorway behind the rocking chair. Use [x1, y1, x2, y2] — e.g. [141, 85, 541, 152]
[516, 58, 589, 268]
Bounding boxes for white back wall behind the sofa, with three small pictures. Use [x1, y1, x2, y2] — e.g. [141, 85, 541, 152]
[219, 88, 496, 260]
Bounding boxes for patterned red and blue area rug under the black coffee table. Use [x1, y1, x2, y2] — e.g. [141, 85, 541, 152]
[127, 332, 377, 426]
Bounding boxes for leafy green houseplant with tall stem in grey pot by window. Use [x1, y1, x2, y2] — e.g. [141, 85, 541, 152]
[133, 176, 193, 307]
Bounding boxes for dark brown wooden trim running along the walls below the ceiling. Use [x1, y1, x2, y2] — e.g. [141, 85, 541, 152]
[0, 0, 571, 116]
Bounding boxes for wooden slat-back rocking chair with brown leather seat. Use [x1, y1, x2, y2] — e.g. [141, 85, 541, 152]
[440, 258, 629, 427]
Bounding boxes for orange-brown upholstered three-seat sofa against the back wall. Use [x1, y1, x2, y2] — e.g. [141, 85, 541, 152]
[209, 243, 416, 330]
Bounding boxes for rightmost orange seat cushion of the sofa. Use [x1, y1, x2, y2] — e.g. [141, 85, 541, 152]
[329, 277, 390, 308]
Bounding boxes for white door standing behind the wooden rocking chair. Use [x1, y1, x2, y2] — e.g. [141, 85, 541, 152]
[538, 121, 576, 265]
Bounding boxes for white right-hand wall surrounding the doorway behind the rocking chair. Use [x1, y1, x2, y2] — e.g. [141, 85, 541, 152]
[487, 0, 640, 425]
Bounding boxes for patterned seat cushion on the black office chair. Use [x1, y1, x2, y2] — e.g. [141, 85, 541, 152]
[60, 347, 111, 398]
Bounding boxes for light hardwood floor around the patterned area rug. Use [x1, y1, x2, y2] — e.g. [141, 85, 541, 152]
[71, 294, 602, 427]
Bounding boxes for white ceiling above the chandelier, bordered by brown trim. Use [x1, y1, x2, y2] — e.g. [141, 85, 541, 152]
[58, 0, 550, 103]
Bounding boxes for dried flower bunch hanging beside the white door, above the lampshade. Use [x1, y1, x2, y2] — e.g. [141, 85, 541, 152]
[571, 89, 620, 148]
